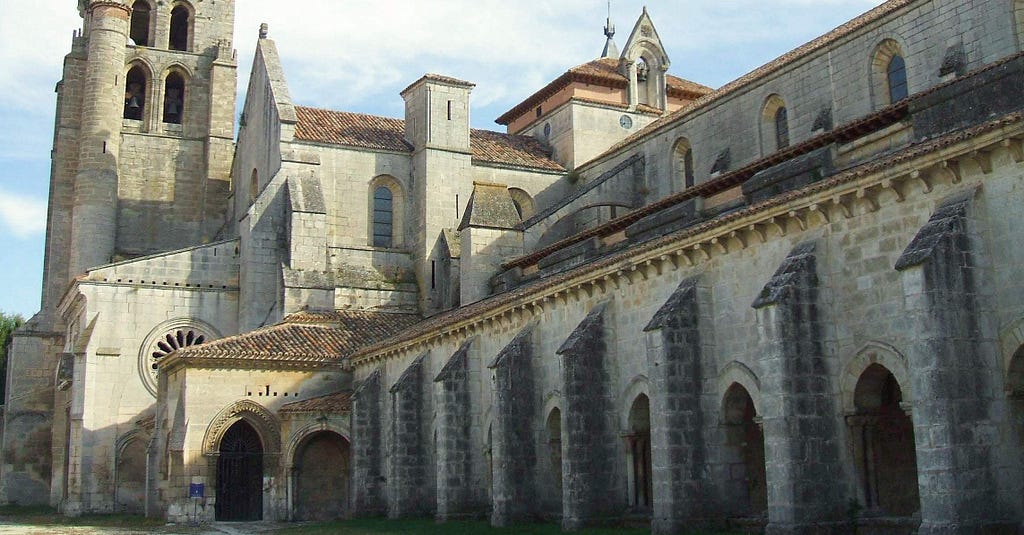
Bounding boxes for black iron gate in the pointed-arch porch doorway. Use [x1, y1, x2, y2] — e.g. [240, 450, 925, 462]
[217, 420, 263, 522]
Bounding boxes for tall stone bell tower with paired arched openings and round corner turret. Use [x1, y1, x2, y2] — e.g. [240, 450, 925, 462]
[43, 0, 237, 311]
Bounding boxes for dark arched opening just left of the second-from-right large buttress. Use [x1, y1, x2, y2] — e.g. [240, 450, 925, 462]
[722, 383, 768, 517]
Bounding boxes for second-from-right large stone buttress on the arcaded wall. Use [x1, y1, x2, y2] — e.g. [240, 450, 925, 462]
[753, 242, 848, 534]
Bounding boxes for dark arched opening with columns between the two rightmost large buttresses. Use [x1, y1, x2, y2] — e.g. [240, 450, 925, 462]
[847, 364, 921, 517]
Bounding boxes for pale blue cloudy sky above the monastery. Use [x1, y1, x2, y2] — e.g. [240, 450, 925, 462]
[0, 0, 882, 317]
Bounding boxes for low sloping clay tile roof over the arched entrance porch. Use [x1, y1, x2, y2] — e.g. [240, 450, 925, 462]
[175, 311, 420, 363]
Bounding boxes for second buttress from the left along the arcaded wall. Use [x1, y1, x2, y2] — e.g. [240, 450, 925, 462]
[387, 355, 429, 519]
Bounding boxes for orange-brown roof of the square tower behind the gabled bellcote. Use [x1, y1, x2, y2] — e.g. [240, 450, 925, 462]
[497, 57, 713, 125]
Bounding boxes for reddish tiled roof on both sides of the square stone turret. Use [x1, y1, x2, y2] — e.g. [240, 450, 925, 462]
[295, 106, 565, 171]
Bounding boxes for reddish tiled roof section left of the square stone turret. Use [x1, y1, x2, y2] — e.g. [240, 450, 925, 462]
[295, 106, 413, 153]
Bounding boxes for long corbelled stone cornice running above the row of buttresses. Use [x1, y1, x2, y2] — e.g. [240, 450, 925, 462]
[350, 113, 1024, 368]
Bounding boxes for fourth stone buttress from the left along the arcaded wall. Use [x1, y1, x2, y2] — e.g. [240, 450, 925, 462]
[487, 326, 538, 527]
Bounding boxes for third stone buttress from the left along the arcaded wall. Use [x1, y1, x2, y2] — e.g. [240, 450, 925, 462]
[434, 338, 473, 521]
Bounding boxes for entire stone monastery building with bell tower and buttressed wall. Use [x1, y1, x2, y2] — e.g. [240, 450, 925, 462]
[0, 0, 1024, 534]
